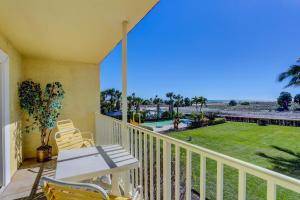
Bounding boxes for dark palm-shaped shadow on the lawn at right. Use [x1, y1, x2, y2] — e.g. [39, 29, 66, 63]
[256, 146, 300, 179]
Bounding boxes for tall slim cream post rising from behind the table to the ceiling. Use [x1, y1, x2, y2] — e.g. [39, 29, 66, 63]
[122, 21, 131, 196]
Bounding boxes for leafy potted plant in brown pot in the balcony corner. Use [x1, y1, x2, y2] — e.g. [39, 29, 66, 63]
[18, 80, 65, 162]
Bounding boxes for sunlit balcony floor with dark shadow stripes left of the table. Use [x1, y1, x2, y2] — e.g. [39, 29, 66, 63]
[0, 158, 56, 200]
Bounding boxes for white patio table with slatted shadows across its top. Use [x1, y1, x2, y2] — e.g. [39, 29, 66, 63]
[55, 145, 139, 195]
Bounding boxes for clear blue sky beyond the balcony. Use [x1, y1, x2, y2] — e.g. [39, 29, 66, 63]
[100, 0, 300, 100]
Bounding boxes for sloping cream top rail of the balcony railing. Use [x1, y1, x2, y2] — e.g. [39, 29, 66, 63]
[127, 119, 300, 193]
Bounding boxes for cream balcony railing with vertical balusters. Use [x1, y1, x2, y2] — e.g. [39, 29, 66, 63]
[96, 114, 300, 200]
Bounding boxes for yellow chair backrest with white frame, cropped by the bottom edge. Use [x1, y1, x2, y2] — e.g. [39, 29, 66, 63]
[40, 177, 109, 200]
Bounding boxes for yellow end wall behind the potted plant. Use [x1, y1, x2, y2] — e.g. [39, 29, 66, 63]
[23, 58, 100, 158]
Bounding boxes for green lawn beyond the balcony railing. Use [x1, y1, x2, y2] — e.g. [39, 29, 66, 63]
[169, 122, 300, 200]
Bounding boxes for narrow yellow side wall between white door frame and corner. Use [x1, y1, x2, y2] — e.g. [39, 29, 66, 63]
[0, 33, 22, 175]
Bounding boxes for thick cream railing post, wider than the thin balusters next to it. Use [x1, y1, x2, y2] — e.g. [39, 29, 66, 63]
[163, 141, 171, 200]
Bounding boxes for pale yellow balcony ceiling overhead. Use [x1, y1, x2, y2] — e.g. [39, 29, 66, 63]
[0, 0, 158, 63]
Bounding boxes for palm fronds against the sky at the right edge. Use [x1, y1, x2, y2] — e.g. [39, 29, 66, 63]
[278, 59, 300, 88]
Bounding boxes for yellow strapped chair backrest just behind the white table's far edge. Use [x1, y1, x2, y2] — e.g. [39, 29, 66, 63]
[54, 128, 84, 151]
